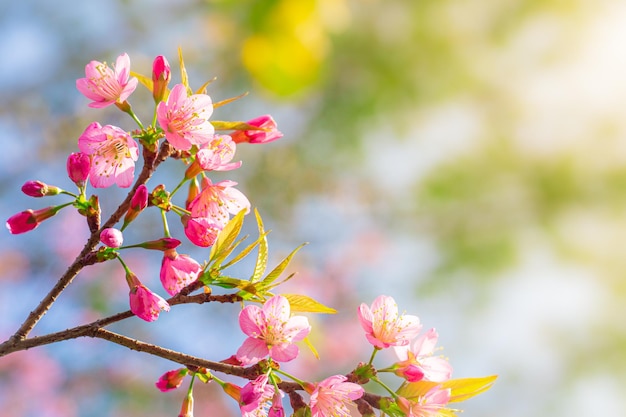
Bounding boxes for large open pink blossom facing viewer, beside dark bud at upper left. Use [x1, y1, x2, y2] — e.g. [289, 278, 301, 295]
[78, 122, 139, 188]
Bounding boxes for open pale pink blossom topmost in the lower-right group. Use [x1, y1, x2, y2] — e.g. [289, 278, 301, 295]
[358, 295, 422, 349]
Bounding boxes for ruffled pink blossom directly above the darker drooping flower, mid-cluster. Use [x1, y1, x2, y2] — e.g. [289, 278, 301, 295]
[188, 178, 250, 227]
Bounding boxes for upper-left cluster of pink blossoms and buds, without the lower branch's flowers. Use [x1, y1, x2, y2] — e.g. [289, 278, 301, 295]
[6, 50, 282, 321]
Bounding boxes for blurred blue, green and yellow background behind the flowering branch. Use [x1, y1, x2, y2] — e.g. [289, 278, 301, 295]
[0, 0, 626, 417]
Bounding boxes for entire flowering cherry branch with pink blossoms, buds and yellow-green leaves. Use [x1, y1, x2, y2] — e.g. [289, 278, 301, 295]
[0, 50, 495, 417]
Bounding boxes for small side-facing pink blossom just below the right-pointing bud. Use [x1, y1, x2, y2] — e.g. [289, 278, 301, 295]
[185, 135, 241, 179]
